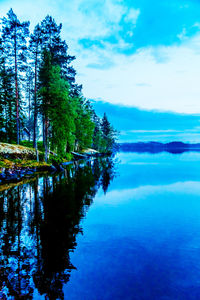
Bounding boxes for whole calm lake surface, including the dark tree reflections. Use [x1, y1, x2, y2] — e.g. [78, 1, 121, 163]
[0, 152, 200, 300]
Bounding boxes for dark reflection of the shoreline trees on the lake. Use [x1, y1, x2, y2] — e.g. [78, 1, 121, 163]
[0, 159, 114, 299]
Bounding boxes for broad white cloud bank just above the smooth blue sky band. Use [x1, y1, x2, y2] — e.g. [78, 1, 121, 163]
[74, 35, 200, 113]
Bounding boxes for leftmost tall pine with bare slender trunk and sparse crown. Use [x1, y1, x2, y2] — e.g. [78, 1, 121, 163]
[2, 9, 29, 144]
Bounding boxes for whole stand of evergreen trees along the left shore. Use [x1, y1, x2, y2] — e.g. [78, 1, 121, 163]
[0, 9, 116, 160]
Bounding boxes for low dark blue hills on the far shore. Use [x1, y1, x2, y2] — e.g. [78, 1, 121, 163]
[119, 142, 200, 153]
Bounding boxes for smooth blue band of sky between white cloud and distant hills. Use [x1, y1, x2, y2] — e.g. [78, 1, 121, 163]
[91, 100, 200, 143]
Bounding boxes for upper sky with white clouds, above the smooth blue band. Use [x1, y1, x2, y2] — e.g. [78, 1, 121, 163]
[0, 0, 200, 142]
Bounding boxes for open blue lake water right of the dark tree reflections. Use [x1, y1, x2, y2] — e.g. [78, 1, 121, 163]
[64, 152, 200, 300]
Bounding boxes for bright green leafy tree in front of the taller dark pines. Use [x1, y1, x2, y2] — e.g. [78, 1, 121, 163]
[39, 49, 75, 160]
